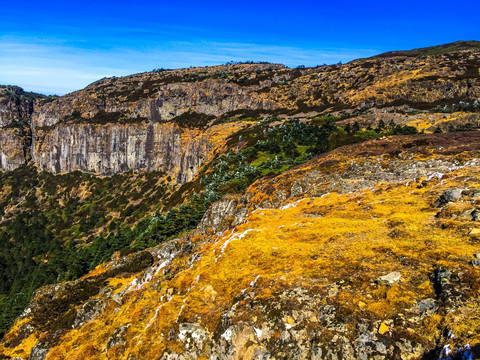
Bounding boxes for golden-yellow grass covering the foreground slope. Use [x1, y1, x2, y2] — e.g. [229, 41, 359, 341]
[0, 133, 480, 359]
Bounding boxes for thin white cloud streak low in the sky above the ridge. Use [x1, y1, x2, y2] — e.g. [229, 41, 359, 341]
[0, 38, 378, 95]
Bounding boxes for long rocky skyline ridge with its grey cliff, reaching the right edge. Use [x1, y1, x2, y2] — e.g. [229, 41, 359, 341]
[0, 41, 480, 176]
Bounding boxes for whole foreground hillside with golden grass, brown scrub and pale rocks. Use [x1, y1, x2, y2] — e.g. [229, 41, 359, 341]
[0, 132, 480, 359]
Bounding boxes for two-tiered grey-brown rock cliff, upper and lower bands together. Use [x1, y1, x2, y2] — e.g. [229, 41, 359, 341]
[33, 65, 281, 177]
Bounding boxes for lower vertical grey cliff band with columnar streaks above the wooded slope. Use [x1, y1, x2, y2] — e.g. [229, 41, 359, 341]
[34, 123, 239, 183]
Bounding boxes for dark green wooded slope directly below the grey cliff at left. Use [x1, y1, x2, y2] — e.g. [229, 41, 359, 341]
[0, 166, 166, 334]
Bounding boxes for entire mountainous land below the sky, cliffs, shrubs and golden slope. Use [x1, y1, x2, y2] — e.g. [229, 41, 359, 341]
[0, 42, 480, 360]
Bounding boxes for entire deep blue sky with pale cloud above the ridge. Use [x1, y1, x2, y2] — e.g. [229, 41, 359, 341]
[0, 0, 480, 95]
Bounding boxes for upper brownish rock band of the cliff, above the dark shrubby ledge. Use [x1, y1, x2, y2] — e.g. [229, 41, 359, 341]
[33, 64, 288, 127]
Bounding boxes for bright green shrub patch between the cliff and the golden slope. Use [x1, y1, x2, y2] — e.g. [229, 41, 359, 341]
[201, 116, 417, 196]
